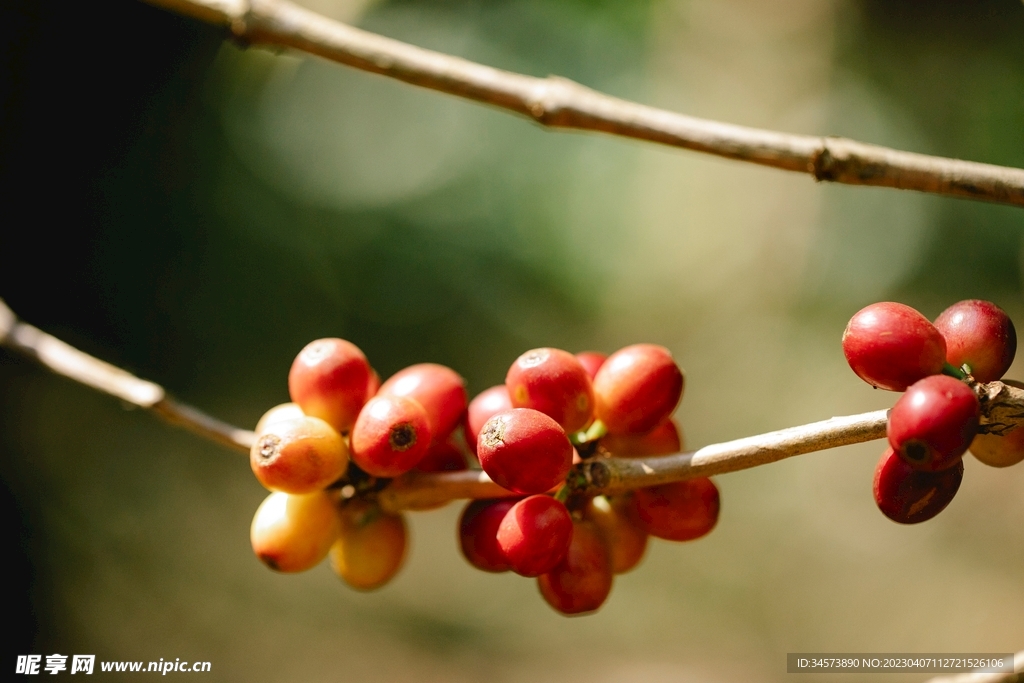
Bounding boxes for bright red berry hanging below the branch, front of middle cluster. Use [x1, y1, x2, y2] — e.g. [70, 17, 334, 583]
[498, 496, 572, 577]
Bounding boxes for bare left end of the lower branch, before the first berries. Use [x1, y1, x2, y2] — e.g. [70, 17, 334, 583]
[0, 299, 255, 453]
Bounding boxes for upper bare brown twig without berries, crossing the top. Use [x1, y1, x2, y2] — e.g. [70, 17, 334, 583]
[136, 0, 1024, 207]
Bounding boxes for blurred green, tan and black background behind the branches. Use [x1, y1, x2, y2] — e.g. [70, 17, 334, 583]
[0, 0, 1024, 683]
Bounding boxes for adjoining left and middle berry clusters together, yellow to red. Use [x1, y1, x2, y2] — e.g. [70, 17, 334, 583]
[243, 339, 719, 613]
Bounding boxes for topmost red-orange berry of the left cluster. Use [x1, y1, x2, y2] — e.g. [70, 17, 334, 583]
[288, 338, 371, 432]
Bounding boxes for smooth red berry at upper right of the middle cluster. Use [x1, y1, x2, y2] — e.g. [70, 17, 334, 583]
[594, 344, 683, 434]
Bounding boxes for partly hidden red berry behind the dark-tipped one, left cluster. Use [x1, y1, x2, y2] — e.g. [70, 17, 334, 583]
[377, 362, 466, 441]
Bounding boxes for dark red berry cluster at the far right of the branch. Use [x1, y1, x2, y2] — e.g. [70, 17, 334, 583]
[843, 299, 1024, 524]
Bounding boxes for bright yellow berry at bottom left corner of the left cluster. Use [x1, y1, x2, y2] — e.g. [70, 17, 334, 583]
[249, 490, 339, 572]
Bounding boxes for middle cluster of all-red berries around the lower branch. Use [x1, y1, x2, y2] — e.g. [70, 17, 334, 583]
[459, 344, 719, 614]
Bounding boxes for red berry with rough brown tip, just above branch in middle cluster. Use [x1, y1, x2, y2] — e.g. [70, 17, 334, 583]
[476, 408, 572, 494]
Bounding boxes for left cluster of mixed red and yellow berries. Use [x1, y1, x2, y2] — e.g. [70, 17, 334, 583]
[249, 339, 467, 590]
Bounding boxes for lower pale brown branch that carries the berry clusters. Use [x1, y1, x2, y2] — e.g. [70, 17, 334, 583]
[6, 299, 1024, 511]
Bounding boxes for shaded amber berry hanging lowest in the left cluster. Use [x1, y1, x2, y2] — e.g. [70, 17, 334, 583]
[330, 499, 409, 591]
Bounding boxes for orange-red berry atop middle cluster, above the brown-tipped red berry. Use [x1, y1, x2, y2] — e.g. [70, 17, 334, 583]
[505, 348, 594, 433]
